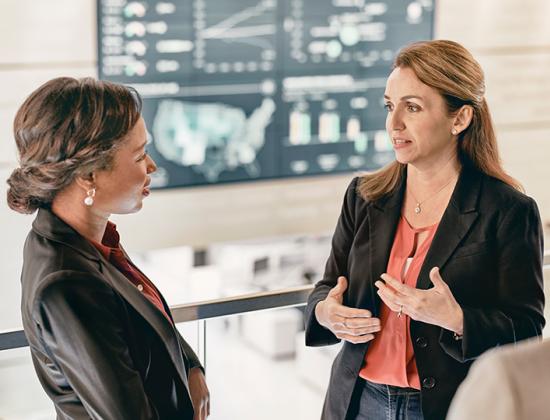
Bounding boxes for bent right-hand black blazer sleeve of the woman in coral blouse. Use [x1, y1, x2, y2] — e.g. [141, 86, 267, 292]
[440, 197, 545, 362]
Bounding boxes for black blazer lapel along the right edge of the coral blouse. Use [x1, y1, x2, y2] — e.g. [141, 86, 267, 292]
[416, 164, 481, 289]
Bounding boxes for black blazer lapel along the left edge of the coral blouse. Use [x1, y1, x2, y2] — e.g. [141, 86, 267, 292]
[367, 176, 407, 316]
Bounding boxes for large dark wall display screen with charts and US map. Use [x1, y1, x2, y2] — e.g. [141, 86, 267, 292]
[98, 0, 434, 187]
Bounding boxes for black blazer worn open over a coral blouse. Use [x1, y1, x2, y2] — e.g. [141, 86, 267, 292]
[306, 164, 544, 420]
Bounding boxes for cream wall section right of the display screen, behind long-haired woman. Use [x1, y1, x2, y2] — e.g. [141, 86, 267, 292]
[436, 0, 550, 223]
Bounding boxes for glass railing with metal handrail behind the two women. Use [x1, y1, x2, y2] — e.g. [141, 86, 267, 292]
[0, 285, 339, 420]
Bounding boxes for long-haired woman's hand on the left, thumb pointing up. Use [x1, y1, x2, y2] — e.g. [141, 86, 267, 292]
[315, 276, 381, 344]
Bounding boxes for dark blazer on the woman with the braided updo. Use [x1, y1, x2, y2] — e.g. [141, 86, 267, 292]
[21, 209, 204, 420]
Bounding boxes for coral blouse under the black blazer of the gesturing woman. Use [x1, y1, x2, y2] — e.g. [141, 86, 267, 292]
[359, 216, 439, 389]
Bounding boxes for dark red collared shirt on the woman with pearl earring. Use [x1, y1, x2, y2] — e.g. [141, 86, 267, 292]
[90, 222, 173, 323]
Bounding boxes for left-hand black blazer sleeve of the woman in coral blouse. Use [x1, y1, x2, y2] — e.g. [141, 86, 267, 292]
[305, 178, 358, 346]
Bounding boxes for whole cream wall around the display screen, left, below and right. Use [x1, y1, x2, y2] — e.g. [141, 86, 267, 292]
[0, 0, 550, 330]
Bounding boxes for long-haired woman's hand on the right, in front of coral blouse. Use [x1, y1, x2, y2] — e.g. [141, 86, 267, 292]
[375, 267, 464, 335]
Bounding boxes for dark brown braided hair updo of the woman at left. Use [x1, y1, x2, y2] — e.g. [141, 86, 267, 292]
[7, 77, 141, 214]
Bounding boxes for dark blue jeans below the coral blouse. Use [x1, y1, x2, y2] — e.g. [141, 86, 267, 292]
[355, 381, 424, 420]
